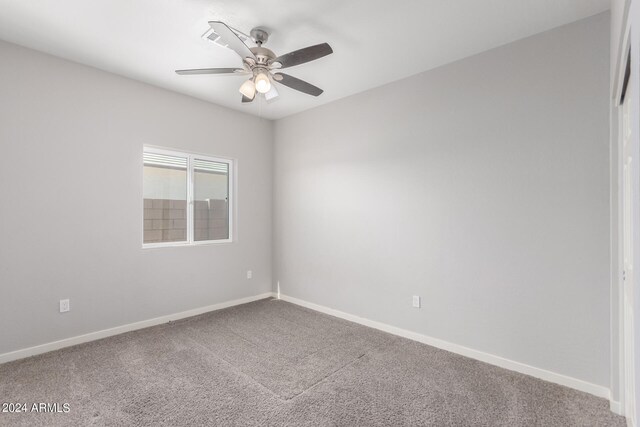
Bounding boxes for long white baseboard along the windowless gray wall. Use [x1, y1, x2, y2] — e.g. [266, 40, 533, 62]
[280, 295, 619, 407]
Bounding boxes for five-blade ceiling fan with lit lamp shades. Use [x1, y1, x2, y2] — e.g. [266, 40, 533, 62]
[176, 21, 333, 102]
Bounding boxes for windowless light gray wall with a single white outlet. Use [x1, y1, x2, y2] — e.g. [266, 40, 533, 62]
[274, 14, 610, 387]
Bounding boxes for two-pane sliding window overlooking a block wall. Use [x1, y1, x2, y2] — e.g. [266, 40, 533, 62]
[142, 147, 233, 247]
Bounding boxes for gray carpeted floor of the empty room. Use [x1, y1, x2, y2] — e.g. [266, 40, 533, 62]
[0, 300, 625, 427]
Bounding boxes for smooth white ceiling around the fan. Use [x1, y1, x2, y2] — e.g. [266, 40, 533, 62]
[0, 0, 609, 119]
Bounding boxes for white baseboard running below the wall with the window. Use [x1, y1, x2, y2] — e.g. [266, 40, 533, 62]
[0, 292, 273, 364]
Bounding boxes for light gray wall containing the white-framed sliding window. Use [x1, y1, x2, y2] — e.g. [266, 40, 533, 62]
[0, 42, 273, 354]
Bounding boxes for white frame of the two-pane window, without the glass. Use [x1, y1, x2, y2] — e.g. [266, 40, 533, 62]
[141, 145, 235, 249]
